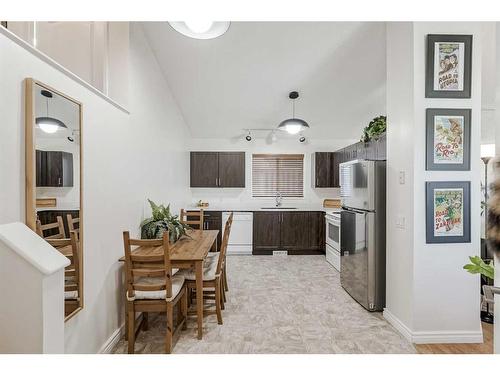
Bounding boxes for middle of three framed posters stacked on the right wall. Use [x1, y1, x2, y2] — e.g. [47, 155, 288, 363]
[425, 108, 471, 171]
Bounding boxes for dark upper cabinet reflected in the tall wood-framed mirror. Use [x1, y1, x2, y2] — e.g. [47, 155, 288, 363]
[36, 150, 73, 187]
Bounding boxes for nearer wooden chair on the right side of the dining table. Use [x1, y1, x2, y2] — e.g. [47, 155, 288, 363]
[182, 214, 233, 324]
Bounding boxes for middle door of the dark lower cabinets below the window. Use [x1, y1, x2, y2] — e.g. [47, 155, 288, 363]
[280, 211, 309, 250]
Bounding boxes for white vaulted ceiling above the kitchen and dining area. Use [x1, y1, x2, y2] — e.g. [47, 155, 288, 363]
[143, 22, 386, 139]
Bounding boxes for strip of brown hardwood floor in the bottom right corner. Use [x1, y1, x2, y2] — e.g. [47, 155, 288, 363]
[415, 323, 493, 354]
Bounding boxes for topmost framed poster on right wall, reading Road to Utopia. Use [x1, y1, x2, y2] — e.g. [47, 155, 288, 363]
[425, 34, 472, 98]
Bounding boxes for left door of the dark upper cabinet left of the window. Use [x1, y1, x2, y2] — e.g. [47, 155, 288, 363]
[190, 152, 219, 187]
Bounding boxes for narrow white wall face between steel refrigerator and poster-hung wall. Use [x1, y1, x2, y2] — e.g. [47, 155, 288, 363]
[386, 22, 415, 332]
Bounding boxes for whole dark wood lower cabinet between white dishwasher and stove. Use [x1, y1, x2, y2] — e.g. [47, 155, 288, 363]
[253, 211, 325, 255]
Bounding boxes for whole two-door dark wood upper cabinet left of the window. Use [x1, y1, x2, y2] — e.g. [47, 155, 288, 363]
[190, 151, 245, 187]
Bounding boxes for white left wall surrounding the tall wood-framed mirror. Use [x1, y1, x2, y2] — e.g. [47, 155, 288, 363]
[0, 25, 189, 353]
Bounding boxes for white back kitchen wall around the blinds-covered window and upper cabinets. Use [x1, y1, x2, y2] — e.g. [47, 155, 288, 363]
[188, 137, 361, 207]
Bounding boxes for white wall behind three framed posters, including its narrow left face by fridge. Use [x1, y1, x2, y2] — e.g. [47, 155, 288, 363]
[387, 22, 482, 342]
